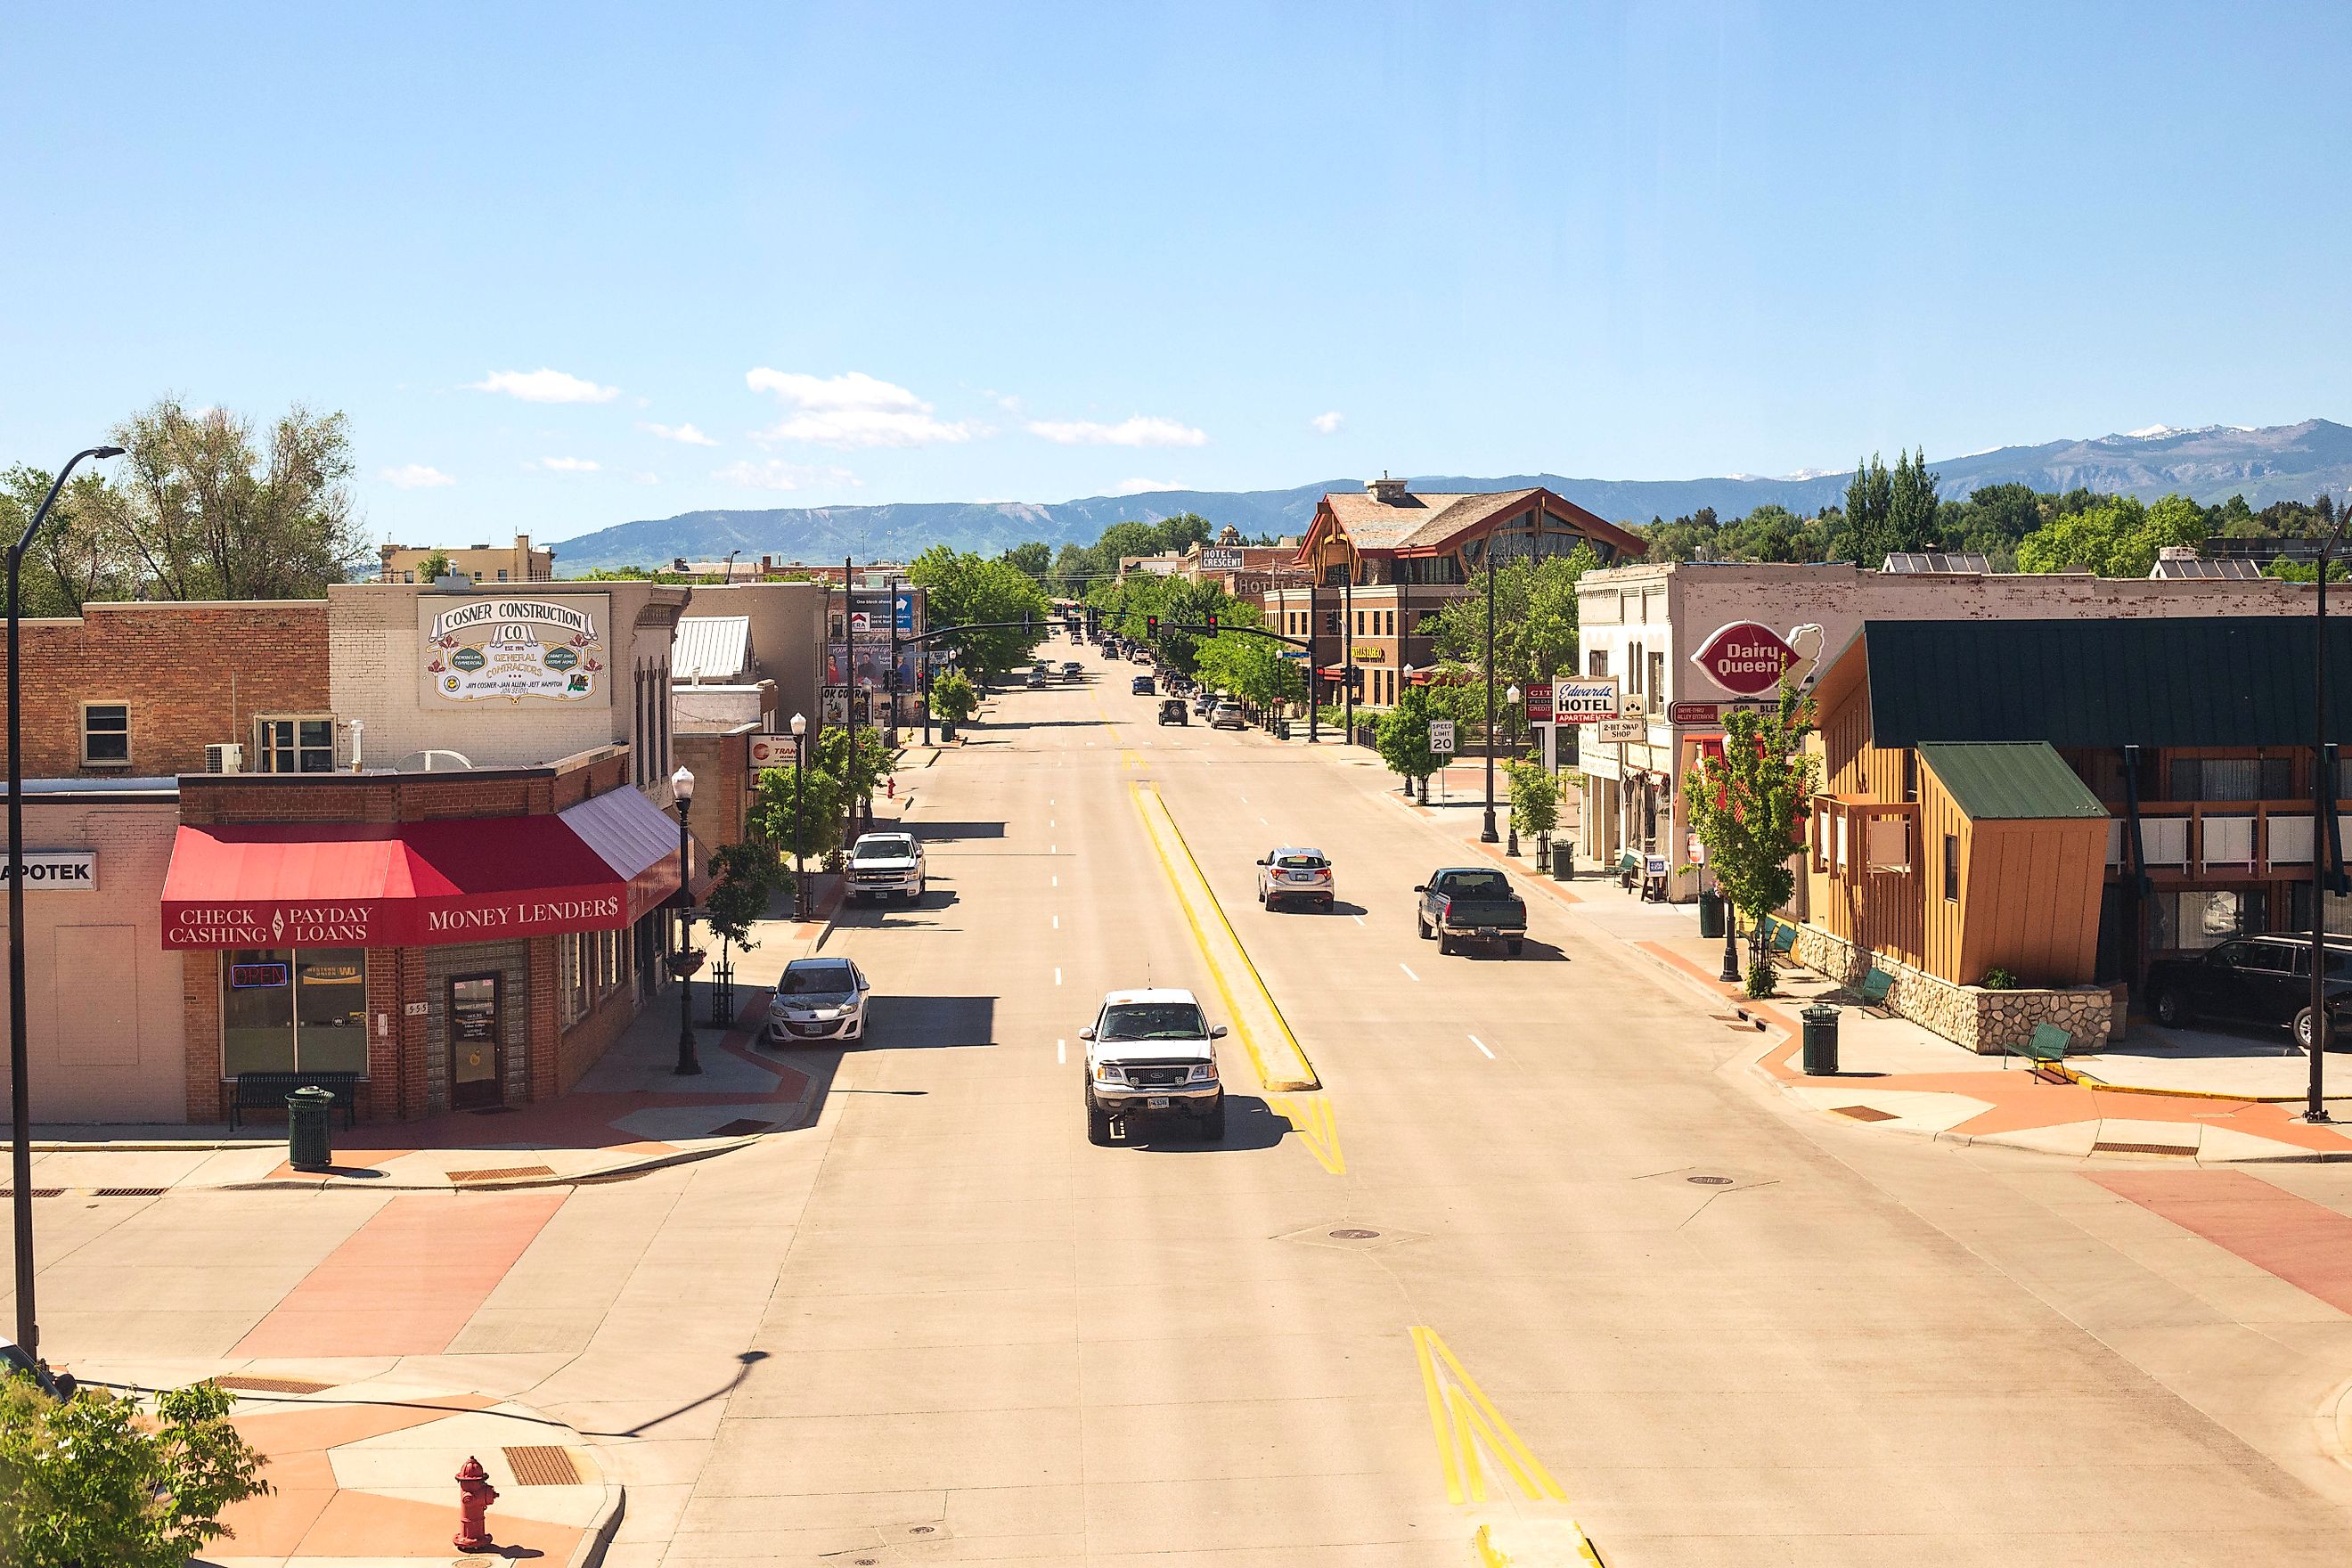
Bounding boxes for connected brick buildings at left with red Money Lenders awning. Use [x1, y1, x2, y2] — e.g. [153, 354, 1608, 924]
[0, 583, 698, 1123]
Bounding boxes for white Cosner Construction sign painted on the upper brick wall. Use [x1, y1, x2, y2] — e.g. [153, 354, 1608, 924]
[416, 592, 611, 707]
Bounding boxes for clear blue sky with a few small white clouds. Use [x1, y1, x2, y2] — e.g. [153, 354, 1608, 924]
[0, 0, 2352, 543]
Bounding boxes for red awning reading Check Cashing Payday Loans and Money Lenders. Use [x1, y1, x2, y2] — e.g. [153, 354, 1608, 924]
[162, 790, 677, 947]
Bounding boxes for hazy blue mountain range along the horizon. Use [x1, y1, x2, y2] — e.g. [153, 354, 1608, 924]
[555, 419, 2352, 576]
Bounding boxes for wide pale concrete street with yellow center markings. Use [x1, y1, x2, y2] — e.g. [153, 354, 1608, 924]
[13, 647, 2352, 1568]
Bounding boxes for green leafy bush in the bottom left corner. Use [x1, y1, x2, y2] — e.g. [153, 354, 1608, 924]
[0, 1376, 271, 1568]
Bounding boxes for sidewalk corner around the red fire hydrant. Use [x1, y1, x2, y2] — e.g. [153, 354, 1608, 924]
[61, 1363, 625, 1568]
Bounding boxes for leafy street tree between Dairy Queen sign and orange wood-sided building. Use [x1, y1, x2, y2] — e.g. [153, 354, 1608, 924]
[1682, 682, 1818, 997]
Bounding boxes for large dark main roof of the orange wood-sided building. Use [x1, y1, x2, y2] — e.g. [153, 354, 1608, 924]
[1863, 616, 2352, 747]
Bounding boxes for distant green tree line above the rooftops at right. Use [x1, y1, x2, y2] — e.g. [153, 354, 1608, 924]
[1632, 452, 2336, 578]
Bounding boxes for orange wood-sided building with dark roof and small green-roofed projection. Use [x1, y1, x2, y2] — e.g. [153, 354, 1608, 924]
[1804, 616, 2352, 987]
